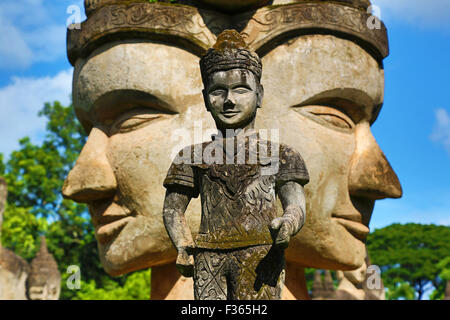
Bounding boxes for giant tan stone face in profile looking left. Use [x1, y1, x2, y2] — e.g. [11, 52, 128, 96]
[63, 41, 207, 275]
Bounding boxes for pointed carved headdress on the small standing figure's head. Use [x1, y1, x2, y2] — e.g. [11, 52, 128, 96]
[200, 30, 262, 83]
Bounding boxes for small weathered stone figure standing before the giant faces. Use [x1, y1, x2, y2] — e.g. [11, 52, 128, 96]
[163, 30, 309, 300]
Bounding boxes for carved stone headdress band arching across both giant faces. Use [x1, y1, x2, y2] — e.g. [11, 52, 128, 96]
[67, 0, 389, 65]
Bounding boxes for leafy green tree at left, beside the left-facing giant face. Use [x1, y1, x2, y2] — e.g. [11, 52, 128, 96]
[0, 102, 149, 299]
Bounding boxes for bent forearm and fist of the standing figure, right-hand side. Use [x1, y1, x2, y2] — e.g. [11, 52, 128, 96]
[270, 181, 306, 248]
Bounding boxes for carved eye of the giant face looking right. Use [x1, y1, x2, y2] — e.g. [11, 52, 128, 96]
[295, 105, 355, 132]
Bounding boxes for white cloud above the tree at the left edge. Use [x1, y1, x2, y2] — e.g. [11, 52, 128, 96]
[0, 69, 73, 156]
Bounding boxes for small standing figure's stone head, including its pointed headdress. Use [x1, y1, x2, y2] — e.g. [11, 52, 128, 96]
[200, 30, 264, 130]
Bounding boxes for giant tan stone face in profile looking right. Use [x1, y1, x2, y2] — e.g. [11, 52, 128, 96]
[256, 35, 401, 270]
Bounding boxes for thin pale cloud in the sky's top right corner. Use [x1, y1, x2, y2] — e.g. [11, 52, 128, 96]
[372, 0, 450, 29]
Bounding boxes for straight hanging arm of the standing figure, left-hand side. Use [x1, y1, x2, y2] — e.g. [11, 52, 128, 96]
[163, 187, 195, 277]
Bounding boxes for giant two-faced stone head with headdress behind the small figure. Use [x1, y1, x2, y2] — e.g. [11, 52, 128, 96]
[63, 0, 402, 299]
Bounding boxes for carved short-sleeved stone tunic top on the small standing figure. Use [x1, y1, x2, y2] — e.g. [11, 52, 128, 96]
[164, 135, 309, 249]
